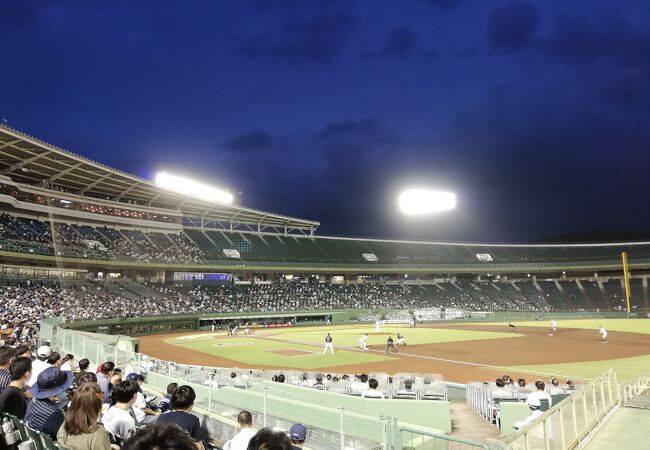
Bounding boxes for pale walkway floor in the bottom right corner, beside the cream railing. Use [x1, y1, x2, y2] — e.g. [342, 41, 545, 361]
[584, 406, 650, 450]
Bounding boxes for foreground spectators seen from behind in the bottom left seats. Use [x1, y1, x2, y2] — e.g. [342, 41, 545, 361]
[0, 345, 312, 450]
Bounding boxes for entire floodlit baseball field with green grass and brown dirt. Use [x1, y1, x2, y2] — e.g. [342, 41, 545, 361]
[140, 319, 650, 383]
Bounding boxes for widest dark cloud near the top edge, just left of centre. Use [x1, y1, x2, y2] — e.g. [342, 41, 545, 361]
[240, 12, 355, 64]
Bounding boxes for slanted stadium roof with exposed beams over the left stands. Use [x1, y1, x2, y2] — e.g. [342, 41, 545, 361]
[0, 124, 320, 232]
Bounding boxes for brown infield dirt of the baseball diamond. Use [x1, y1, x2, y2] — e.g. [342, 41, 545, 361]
[140, 324, 650, 383]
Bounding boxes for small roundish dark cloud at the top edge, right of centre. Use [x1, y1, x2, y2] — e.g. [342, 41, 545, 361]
[487, 2, 539, 52]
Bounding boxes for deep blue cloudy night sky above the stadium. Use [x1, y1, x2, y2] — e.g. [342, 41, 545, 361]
[0, 0, 650, 241]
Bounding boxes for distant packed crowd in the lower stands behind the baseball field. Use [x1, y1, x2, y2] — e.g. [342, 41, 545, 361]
[0, 280, 568, 333]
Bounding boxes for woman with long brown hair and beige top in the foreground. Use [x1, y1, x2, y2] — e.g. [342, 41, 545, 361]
[56, 383, 111, 450]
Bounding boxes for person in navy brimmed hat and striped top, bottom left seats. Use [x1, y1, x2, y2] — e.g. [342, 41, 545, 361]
[25, 367, 74, 439]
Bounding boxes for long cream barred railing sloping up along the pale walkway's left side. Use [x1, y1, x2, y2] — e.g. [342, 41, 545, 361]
[503, 369, 619, 450]
